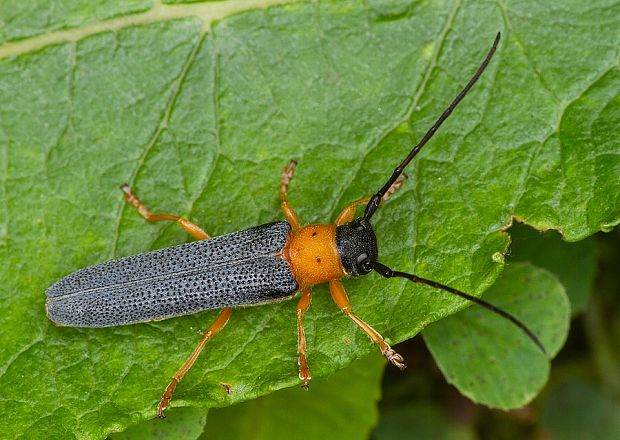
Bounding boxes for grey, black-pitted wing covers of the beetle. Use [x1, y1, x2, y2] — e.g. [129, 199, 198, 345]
[46, 222, 298, 327]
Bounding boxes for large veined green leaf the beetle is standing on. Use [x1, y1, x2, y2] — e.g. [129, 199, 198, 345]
[0, 0, 620, 438]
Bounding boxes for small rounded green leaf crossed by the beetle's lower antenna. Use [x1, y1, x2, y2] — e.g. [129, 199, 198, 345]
[424, 263, 570, 410]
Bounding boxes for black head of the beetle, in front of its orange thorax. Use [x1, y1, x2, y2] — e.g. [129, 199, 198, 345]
[336, 217, 378, 277]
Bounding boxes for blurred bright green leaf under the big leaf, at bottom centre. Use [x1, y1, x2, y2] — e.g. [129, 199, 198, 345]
[204, 353, 385, 440]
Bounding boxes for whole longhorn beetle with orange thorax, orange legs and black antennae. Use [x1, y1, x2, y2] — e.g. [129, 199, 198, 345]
[46, 33, 545, 417]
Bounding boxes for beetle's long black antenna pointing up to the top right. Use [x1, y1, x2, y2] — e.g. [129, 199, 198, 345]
[364, 32, 501, 220]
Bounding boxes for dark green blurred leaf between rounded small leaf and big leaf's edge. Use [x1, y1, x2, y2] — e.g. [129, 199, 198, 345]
[510, 224, 596, 315]
